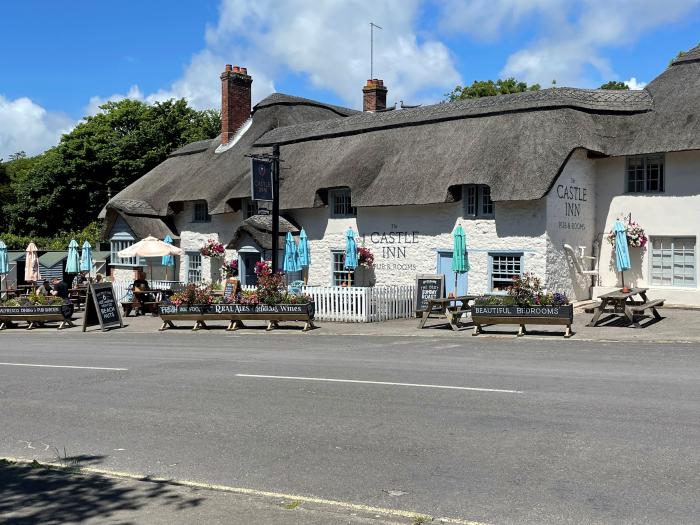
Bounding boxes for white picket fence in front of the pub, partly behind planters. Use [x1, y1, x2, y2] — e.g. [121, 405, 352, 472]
[108, 281, 416, 323]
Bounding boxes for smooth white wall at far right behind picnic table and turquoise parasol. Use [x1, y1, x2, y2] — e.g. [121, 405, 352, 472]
[595, 151, 700, 305]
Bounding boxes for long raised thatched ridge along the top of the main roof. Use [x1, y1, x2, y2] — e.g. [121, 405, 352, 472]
[256, 88, 652, 146]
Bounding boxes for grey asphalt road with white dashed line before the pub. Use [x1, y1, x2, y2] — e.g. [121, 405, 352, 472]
[0, 331, 700, 524]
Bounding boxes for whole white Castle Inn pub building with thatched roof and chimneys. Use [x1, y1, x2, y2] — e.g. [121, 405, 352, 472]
[102, 46, 700, 305]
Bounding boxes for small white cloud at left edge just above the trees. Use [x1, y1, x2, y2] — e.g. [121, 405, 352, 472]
[0, 95, 75, 160]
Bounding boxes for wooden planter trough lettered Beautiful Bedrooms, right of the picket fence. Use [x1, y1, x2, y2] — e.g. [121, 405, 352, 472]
[471, 304, 574, 337]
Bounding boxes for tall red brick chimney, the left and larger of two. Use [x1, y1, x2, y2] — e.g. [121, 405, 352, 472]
[221, 64, 253, 144]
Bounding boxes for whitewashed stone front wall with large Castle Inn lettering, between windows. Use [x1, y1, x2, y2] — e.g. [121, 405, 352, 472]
[293, 196, 546, 293]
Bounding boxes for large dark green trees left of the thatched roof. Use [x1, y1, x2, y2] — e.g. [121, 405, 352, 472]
[0, 99, 220, 236]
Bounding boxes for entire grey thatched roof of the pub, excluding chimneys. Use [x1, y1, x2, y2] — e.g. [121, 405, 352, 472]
[108, 46, 700, 217]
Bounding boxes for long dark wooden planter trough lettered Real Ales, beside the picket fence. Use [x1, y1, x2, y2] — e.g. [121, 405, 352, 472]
[158, 302, 316, 332]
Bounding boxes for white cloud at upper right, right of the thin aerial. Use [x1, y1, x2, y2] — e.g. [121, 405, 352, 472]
[443, 0, 700, 86]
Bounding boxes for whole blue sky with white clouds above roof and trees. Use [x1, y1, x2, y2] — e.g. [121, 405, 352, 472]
[0, 0, 700, 158]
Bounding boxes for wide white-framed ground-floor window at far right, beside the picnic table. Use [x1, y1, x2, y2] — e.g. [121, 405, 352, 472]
[650, 237, 696, 288]
